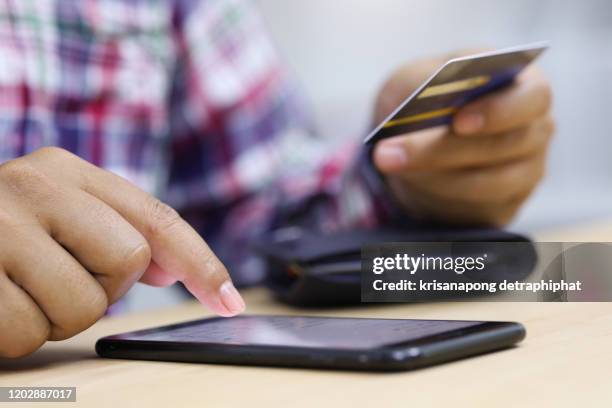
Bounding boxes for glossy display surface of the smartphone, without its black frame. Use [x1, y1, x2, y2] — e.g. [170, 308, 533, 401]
[109, 316, 484, 350]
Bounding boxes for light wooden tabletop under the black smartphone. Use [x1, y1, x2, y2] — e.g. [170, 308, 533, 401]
[0, 223, 612, 407]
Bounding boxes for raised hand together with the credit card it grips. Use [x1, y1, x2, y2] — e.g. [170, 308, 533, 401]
[366, 43, 555, 226]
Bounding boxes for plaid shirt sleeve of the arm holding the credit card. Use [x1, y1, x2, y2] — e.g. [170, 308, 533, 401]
[166, 0, 391, 285]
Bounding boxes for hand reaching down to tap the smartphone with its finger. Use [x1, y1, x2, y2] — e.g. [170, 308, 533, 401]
[0, 148, 244, 357]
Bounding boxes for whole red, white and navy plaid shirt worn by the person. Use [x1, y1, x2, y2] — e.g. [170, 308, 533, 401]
[0, 0, 392, 285]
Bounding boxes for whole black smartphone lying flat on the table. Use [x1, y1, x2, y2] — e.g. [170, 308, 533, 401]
[96, 315, 525, 371]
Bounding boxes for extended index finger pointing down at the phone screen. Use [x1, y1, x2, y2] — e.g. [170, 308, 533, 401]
[30, 149, 245, 316]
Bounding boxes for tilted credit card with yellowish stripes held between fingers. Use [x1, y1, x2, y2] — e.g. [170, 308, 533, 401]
[364, 42, 548, 143]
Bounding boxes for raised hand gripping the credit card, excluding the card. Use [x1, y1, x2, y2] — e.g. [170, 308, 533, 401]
[374, 52, 554, 226]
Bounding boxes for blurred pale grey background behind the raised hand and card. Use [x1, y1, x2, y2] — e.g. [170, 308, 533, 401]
[128, 0, 612, 310]
